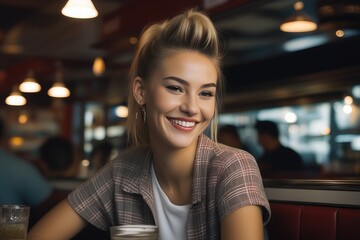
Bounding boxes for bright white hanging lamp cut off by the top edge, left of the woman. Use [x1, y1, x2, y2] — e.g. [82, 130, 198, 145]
[61, 0, 98, 19]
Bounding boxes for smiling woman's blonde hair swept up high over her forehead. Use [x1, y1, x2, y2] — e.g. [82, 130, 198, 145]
[127, 9, 224, 146]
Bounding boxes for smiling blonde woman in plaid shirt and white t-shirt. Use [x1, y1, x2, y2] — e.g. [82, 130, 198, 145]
[29, 10, 270, 240]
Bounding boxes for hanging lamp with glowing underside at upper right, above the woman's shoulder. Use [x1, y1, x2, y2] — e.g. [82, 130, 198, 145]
[280, 1, 317, 32]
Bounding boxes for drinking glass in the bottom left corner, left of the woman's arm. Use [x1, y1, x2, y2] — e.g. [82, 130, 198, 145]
[0, 205, 30, 240]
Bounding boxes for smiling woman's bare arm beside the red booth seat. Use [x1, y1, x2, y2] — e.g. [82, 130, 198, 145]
[221, 206, 264, 240]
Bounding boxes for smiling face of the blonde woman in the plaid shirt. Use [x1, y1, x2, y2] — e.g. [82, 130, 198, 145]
[144, 50, 217, 148]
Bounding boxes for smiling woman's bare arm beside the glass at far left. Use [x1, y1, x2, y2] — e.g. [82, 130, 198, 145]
[27, 199, 87, 240]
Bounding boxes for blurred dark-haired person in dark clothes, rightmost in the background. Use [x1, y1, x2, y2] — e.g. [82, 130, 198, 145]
[255, 121, 304, 173]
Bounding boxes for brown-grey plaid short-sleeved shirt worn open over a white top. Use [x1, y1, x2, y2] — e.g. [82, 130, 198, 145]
[68, 135, 270, 240]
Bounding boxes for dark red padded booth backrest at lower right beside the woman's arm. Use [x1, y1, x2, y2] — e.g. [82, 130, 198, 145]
[267, 202, 360, 240]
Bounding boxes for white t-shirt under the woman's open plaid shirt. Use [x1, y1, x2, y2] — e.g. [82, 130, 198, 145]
[151, 167, 191, 240]
